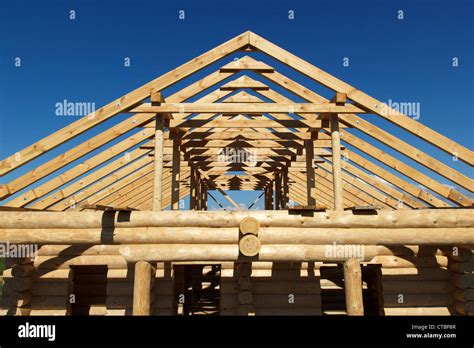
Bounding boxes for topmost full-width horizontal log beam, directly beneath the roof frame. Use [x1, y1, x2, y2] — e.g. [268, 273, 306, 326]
[0, 208, 474, 232]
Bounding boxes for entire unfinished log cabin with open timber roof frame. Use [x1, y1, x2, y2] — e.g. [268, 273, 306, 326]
[0, 32, 474, 315]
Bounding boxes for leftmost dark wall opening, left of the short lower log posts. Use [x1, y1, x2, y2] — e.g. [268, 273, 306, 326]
[69, 266, 108, 315]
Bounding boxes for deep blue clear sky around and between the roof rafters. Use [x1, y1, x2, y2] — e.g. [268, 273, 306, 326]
[0, 0, 474, 208]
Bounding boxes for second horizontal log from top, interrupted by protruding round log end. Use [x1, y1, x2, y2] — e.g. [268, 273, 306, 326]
[0, 227, 474, 245]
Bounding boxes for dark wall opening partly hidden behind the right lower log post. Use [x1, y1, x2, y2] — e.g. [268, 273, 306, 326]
[320, 264, 384, 315]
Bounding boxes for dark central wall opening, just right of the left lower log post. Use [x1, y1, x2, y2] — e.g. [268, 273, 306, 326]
[173, 264, 221, 315]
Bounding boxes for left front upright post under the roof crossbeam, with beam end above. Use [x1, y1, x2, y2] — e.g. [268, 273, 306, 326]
[154, 92, 165, 211]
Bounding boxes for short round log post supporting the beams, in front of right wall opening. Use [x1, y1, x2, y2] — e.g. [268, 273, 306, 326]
[344, 257, 364, 315]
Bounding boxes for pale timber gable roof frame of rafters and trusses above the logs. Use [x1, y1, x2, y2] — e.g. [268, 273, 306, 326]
[0, 32, 474, 210]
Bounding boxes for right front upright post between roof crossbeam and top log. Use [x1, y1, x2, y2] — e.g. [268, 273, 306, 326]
[330, 114, 344, 210]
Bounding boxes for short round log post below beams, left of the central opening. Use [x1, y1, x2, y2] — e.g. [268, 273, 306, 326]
[133, 261, 153, 315]
